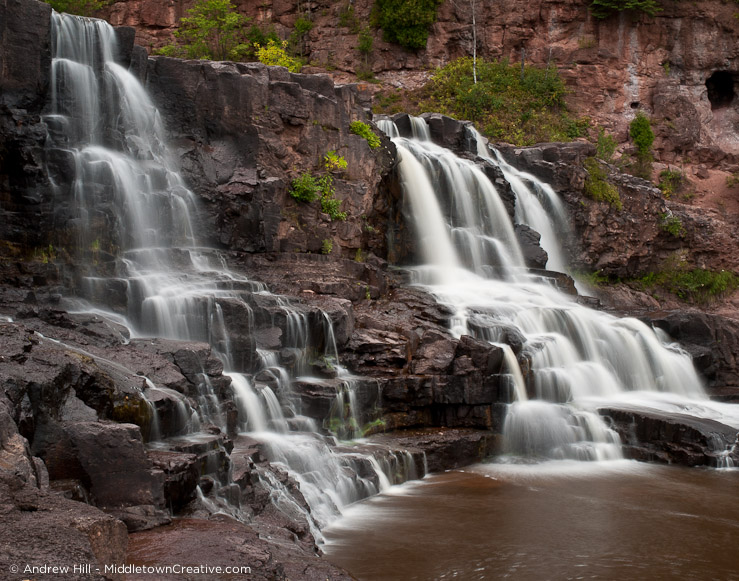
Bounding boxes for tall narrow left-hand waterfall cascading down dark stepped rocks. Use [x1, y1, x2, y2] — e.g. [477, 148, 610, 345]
[46, 12, 422, 539]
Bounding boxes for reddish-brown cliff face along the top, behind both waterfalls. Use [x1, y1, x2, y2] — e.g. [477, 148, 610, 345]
[102, 0, 739, 165]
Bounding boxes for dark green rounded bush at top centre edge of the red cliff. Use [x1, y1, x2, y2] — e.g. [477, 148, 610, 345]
[372, 0, 442, 50]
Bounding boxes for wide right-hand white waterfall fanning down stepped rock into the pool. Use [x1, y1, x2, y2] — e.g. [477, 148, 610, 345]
[378, 119, 739, 460]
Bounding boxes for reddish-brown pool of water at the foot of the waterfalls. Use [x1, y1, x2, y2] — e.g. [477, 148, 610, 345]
[324, 461, 739, 581]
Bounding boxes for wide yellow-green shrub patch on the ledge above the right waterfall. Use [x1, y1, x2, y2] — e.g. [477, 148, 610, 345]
[418, 57, 587, 145]
